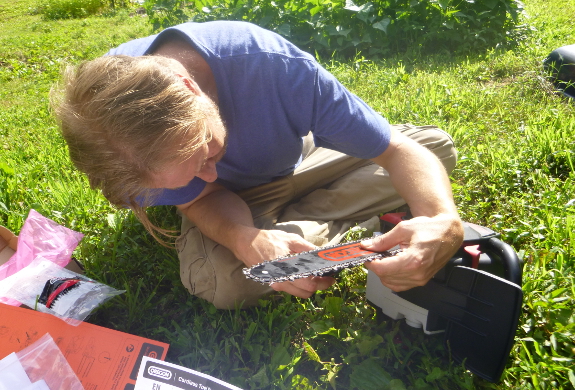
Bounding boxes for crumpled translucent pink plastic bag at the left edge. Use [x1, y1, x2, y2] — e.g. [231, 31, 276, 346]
[0, 209, 84, 306]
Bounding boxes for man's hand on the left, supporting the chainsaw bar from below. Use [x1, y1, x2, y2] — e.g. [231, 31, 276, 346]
[235, 228, 335, 298]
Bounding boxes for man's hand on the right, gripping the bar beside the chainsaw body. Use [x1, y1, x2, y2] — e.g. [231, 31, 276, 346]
[362, 214, 463, 291]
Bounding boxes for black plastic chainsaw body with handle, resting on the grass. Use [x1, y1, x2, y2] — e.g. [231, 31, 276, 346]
[376, 213, 523, 382]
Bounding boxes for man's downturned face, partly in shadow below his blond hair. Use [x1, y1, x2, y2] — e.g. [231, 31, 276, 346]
[150, 96, 227, 189]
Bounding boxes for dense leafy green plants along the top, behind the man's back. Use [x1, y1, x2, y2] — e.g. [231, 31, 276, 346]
[144, 0, 525, 58]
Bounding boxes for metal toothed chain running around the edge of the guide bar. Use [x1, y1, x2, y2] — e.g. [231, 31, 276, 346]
[243, 240, 401, 285]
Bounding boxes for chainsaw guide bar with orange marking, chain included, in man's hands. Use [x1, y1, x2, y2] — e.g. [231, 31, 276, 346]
[243, 240, 401, 285]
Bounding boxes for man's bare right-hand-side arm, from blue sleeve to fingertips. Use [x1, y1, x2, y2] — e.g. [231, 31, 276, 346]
[364, 132, 463, 291]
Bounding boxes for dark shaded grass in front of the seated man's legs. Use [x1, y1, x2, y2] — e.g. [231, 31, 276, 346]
[83, 207, 482, 389]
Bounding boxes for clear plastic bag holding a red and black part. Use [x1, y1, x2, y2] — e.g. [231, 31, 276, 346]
[0, 256, 124, 326]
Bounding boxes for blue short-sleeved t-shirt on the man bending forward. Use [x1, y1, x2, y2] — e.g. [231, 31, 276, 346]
[107, 21, 390, 205]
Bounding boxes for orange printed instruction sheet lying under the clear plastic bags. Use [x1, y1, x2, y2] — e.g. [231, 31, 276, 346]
[0, 303, 169, 390]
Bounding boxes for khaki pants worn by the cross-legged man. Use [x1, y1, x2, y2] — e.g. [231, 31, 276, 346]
[176, 125, 457, 309]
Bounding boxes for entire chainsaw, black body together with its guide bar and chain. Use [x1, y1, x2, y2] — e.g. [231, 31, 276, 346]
[243, 213, 523, 382]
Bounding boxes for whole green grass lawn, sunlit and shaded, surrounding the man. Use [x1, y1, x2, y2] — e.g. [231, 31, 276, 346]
[0, 0, 575, 389]
